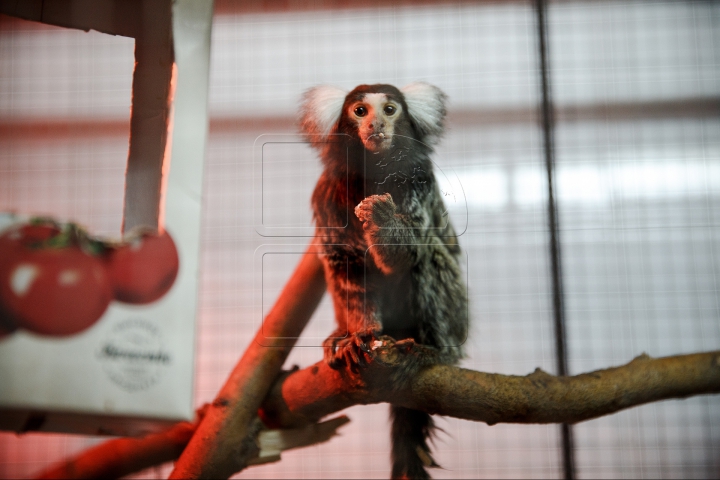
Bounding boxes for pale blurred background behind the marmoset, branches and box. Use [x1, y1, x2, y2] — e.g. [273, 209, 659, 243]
[0, 0, 720, 478]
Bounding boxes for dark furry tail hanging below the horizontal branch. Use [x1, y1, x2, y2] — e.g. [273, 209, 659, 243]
[390, 405, 438, 480]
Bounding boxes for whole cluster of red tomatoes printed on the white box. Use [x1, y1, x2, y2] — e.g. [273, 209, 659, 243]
[0, 218, 179, 338]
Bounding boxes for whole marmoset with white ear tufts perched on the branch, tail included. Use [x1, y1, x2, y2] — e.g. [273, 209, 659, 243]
[300, 83, 468, 478]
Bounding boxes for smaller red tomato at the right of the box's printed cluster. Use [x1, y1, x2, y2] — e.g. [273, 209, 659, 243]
[108, 232, 180, 304]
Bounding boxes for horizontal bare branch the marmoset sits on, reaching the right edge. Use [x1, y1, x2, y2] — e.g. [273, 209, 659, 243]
[262, 340, 720, 426]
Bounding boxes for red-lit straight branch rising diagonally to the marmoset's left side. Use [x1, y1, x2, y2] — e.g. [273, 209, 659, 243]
[170, 245, 325, 478]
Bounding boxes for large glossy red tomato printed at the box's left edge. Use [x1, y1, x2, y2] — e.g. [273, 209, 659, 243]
[0, 225, 112, 335]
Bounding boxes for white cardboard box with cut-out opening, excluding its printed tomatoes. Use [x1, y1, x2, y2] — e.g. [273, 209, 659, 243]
[0, 0, 212, 435]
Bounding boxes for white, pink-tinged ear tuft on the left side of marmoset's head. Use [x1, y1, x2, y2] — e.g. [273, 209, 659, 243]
[300, 85, 347, 138]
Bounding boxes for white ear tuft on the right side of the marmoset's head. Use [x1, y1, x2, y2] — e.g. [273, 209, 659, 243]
[400, 82, 447, 145]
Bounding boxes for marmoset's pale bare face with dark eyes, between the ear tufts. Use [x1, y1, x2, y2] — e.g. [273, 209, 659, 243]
[345, 93, 404, 153]
